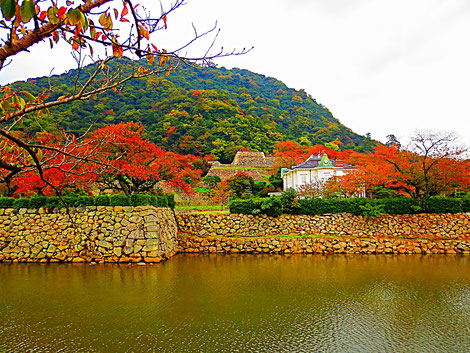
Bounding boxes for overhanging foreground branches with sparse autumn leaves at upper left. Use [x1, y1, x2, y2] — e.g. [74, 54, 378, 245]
[0, 0, 253, 193]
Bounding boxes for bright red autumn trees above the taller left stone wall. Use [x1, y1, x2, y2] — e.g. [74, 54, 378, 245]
[0, 122, 207, 196]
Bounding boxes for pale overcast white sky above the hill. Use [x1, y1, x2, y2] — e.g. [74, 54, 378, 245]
[0, 0, 470, 145]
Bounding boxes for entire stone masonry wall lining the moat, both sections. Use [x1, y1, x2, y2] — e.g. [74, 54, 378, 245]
[0, 206, 470, 263]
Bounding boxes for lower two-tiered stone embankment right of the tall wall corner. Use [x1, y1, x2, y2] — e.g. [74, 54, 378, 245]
[177, 213, 470, 254]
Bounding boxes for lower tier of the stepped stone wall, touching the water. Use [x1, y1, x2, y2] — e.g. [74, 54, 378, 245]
[178, 236, 470, 254]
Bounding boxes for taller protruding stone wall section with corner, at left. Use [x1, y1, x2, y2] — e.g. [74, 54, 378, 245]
[0, 206, 177, 263]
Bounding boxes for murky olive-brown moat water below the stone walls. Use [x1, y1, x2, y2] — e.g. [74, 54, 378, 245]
[0, 254, 470, 352]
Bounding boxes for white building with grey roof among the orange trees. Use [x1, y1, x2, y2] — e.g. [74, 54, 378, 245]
[281, 153, 356, 190]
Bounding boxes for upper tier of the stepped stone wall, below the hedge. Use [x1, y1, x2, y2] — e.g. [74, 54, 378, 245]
[177, 213, 470, 239]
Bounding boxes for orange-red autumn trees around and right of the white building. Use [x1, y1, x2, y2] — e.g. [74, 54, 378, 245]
[274, 132, 470, 207]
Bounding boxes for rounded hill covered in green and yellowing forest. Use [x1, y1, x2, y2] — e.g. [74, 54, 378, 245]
[11, 60, 374, 161]
